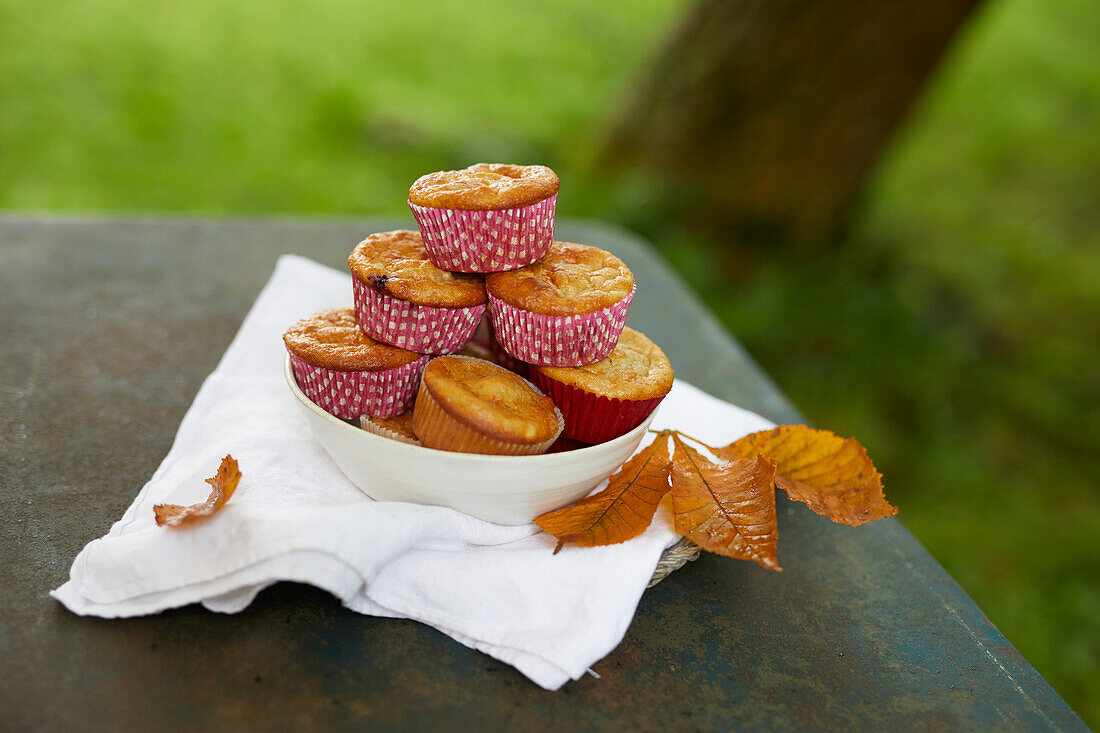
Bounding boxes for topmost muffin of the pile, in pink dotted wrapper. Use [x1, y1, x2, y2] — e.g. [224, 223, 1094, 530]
[408, 163, 560, 272]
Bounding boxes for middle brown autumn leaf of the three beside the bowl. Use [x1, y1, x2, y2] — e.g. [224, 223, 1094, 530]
[672, 436, 782, 570]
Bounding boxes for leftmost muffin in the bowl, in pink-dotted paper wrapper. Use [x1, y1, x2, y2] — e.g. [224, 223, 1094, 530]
[283, 308, 428, 419]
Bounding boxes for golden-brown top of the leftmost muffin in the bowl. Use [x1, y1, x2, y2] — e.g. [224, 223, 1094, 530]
[283, 308, 420, 372]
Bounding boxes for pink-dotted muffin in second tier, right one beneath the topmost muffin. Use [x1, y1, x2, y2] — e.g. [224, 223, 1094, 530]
[485, 242, 636, 367]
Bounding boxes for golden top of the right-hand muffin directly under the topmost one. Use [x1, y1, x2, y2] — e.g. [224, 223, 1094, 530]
[485, 242, 634, 316]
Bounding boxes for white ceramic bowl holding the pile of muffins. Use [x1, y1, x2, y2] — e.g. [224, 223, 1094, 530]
[284, 357, 653, 524]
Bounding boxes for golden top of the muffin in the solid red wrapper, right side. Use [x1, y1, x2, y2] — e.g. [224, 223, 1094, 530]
[531, 328, 672, 400]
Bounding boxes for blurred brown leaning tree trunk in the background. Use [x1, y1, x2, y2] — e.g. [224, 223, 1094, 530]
[604, 0, 978, 245]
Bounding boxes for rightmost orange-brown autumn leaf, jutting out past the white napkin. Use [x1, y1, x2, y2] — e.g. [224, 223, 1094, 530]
[715, 425, 898, 527]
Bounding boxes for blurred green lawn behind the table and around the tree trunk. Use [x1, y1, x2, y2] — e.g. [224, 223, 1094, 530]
[0, 0, 1100, 724]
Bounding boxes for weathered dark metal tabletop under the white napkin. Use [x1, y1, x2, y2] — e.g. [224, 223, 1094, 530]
[0, 217, 1085, 730]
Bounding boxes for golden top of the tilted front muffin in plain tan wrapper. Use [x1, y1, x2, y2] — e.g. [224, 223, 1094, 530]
[422, 357, 561, 445]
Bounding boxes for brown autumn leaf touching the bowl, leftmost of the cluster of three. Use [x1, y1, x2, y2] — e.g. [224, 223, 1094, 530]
[535, 430, 670, 553]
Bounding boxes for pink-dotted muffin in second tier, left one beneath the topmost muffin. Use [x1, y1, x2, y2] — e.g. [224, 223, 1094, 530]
[348, 230, 486, 353]
